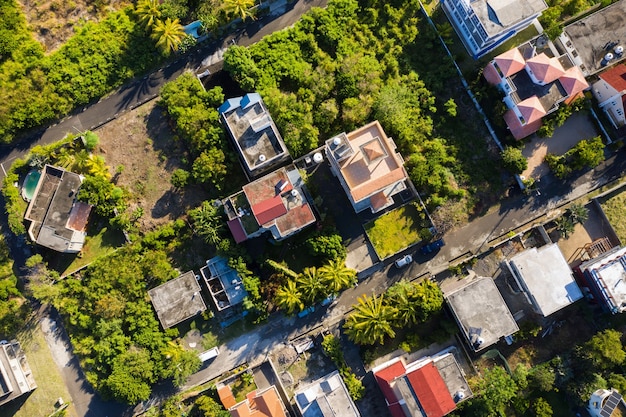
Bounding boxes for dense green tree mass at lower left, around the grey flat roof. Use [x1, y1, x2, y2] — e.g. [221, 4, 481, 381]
[34, 222, 200, 404]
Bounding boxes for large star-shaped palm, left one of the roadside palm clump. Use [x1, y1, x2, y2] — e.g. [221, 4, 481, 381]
[344, 295, 397, 345]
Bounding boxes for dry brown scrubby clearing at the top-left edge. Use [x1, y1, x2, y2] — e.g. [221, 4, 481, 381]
[19, 0, 131, 52]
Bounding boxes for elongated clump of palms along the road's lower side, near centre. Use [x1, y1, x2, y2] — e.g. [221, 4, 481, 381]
[344, 280, 443, 345]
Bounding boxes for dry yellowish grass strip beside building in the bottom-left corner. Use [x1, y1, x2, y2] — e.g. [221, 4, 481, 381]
[0, 319, 76, 417]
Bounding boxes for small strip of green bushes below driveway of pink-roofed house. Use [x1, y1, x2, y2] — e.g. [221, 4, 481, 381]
[545, 136, 604, 179]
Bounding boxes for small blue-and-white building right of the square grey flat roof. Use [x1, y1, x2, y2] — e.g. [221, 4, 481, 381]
[200, 256, 248, 311]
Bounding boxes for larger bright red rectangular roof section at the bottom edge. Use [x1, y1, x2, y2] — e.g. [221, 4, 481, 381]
[407, 362, 456, 417]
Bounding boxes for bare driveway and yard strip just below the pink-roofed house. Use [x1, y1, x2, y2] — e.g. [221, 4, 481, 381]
[522, 112, 599, 179]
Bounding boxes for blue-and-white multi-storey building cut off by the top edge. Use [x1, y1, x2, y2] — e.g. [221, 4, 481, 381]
[441, 0, 548, 59]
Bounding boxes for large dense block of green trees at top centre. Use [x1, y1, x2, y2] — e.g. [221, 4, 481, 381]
[224, 0, 497, 206]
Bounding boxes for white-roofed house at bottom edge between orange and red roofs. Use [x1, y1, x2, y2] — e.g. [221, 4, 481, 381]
[294, 371, 361, 417]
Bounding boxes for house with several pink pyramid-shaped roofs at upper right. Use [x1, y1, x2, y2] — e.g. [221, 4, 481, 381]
[483, 38, 589, 139]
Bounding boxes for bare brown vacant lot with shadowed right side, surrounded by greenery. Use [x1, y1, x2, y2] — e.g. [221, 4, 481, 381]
[96, 100, 208, 232]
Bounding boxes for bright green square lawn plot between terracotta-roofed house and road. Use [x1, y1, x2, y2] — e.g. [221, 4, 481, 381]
[365, 204, 430, 259]
